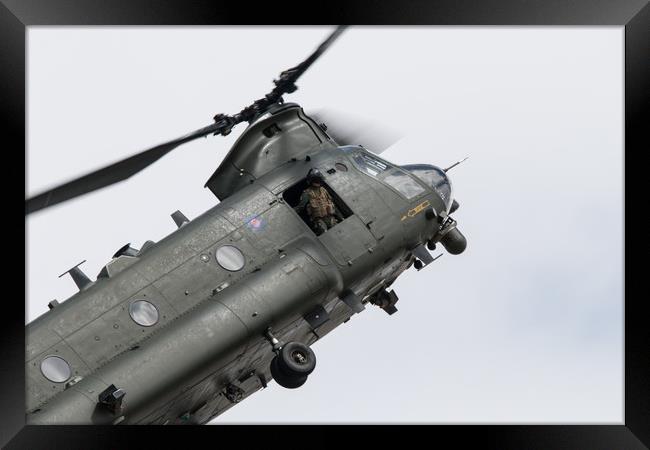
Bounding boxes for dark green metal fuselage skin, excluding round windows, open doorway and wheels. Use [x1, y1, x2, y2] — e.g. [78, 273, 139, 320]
[26, 104, 460, 424]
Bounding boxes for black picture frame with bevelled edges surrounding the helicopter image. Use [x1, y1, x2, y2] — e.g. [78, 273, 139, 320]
[0, 0, 650, 449]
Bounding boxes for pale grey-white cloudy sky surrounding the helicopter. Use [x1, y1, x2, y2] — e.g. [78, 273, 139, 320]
[26, 27, 623, 423]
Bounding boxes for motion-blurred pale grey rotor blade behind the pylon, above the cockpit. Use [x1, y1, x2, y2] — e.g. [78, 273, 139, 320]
[308, 109, 404, 154]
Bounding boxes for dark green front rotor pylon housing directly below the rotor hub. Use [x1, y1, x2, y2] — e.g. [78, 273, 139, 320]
[205, 103, 336, 201]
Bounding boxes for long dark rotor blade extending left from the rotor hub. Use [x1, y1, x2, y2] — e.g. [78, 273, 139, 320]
[25, 122, 223, 214]
